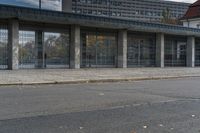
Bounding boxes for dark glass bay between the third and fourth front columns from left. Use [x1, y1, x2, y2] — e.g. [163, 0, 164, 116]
[127, 33, 156, 67]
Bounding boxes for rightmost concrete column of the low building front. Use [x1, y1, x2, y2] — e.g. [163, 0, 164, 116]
[187, 37, 195, 67]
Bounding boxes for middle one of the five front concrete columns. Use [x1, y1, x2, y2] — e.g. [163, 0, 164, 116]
[117, 30, 127, 68]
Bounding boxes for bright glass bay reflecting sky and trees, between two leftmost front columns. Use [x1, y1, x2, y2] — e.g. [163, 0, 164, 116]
[19, 31, 69, 69]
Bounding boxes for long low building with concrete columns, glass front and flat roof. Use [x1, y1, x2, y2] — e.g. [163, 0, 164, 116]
[0, 5, 200, 70]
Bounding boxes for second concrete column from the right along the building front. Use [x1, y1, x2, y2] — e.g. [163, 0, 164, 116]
[156, 33, 165, 68]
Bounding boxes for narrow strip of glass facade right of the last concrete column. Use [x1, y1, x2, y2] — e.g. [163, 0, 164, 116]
[195, 39, 200, 66]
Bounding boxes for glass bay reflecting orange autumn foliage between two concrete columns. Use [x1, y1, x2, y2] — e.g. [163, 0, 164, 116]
[81, 32, 117, 67]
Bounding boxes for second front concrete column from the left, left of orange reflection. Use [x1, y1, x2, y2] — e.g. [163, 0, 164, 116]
[70, 25, 80, 69]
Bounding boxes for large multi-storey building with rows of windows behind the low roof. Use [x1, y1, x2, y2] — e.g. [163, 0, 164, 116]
[62, 0, 189, 21]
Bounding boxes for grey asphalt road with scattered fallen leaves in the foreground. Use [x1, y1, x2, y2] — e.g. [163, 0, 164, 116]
[0, 78, 200, 133]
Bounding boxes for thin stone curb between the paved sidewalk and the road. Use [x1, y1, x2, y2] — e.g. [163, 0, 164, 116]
[0, 75, 200, 86]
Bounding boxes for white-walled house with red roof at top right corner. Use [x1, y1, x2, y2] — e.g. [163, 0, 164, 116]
[181, 0, 200, 29]
